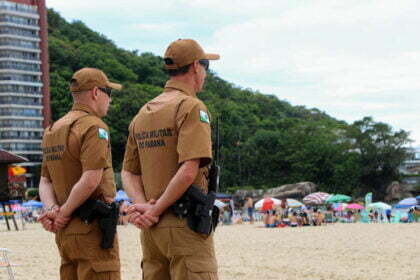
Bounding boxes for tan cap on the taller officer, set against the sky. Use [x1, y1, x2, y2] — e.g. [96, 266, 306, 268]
[163, 39, 220, 70]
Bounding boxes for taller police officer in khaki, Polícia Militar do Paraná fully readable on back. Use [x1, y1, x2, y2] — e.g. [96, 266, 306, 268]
[122, 39, 219, 280]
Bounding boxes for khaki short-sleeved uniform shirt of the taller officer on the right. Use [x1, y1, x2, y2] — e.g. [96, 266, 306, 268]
[123, 81, 212, 203]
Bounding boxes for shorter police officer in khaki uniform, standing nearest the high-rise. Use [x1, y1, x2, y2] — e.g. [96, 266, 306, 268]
[39, 68, 121, 280]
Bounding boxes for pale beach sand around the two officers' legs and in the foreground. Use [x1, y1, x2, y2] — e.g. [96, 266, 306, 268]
[0, 221, 420, 280]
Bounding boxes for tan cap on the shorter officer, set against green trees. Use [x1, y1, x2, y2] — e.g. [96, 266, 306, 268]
[70, 68, 122, 92]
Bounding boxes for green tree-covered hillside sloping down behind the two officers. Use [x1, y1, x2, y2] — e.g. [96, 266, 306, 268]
[48, 10, 408, 197]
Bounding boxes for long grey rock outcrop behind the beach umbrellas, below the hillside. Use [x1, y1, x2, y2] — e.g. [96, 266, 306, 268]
[233, 182, 317, 201]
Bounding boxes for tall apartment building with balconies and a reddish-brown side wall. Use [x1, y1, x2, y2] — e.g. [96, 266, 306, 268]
[0, 0, 51, 171]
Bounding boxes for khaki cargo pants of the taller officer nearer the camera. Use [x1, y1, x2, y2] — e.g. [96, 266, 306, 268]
[140, 217, 218, 280]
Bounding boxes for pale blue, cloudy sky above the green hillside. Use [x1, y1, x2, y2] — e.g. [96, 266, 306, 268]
[47, 0, 420, 146]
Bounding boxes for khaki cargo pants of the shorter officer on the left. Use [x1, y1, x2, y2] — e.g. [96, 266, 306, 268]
[56, 218, 121, 280]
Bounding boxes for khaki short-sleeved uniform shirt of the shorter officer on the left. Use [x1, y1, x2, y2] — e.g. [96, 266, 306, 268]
[41, 103, 116, 223]
